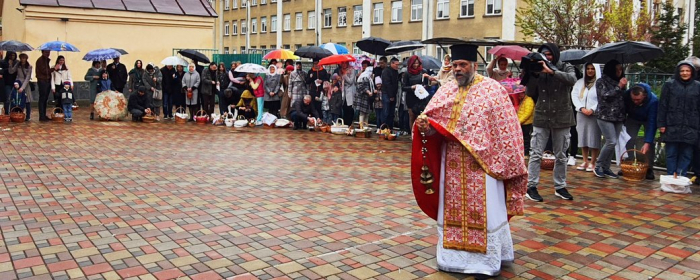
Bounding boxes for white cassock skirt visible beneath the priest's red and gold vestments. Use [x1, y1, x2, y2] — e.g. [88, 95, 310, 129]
[436, 144, 515, 276]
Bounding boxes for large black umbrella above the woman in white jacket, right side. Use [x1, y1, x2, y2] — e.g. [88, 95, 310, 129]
[581, 41, 664, 64]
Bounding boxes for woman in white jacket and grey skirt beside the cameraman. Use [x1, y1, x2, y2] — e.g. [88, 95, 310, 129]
[571, 63, 601, 172]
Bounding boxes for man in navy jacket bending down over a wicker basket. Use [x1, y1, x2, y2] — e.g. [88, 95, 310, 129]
[619, 83, 659, 180]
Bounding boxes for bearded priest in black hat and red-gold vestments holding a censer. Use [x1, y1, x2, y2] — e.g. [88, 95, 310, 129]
[411, 44, 527, 276]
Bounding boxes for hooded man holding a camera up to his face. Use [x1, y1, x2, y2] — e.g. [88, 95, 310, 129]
[524, 43, 576, 202]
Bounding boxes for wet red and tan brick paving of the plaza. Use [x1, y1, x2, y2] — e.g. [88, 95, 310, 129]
[0, 109, 700, 280]
